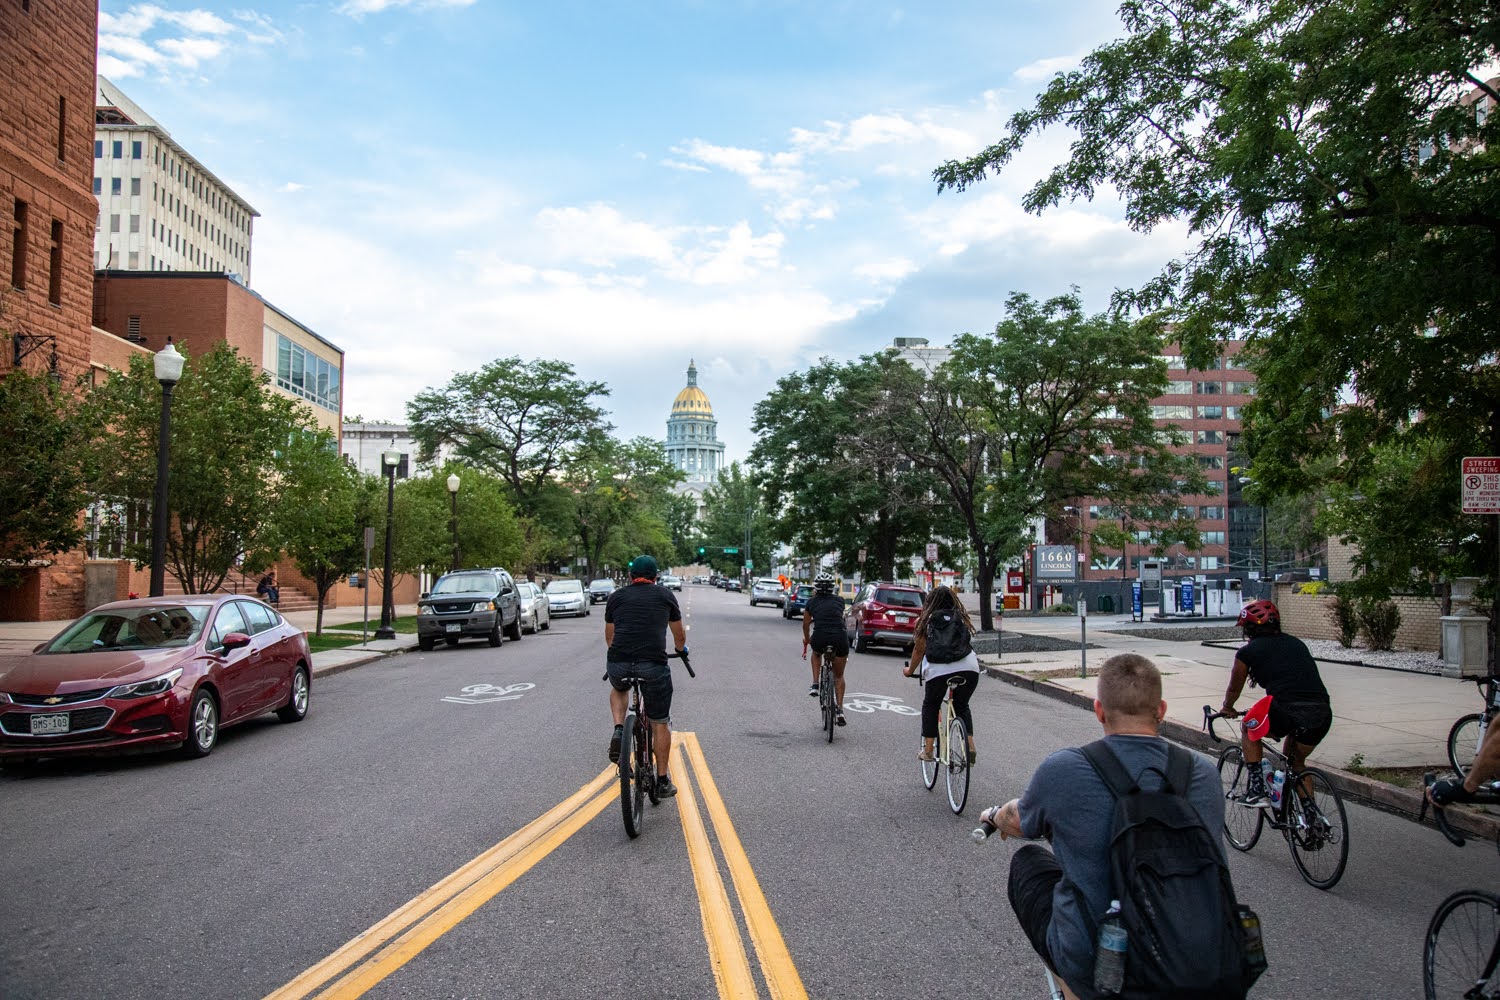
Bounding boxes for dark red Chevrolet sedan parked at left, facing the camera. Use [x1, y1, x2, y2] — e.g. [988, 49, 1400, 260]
[0, 594, 312, 759]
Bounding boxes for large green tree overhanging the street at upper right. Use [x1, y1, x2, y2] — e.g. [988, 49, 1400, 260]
[935, 0, 1500, 663]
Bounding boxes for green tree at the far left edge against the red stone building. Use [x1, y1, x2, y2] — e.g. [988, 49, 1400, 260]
[0, 369, 92, 586]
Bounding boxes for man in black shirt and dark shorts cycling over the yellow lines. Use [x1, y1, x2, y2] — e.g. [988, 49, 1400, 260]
[605, 556, 687, 798]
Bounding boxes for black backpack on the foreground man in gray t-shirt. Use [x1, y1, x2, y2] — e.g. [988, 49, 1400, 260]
[1082, 741, 1265, 1000]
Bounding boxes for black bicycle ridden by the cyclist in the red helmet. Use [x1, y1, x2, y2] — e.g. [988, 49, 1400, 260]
[1203, 705, 1349, 889]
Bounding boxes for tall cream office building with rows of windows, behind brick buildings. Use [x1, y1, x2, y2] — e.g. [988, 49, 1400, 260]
[93, 76, 260, 286]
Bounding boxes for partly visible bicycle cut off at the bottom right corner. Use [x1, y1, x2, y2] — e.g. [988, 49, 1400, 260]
[1418, 774, 1500, 1000]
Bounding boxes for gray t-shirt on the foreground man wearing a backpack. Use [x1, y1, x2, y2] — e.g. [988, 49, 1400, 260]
[1020, 736, 1224, 984]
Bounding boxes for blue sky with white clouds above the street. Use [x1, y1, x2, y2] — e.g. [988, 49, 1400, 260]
[99, 0, 1185, 460]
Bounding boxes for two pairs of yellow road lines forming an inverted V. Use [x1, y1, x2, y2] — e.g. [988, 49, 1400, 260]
[266, 733, 807, 1000]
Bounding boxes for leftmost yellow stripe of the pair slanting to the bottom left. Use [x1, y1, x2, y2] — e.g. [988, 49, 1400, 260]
[266, 768, 617, 1000]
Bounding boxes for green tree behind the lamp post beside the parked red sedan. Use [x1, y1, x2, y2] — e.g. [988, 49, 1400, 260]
[84, 343, 314, 594]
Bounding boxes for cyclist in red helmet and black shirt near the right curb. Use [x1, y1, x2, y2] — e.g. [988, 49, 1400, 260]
[1221, 601, 1334, 808]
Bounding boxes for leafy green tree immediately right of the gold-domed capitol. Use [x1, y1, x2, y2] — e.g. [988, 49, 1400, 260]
[750, 354, 938, 580]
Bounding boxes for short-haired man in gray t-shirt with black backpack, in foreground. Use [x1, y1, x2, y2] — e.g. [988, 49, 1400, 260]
[980, 654, 1259, 1000]
